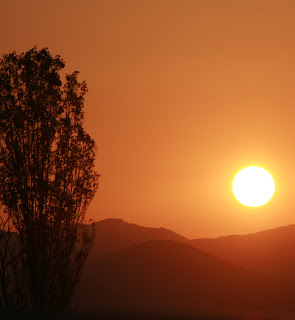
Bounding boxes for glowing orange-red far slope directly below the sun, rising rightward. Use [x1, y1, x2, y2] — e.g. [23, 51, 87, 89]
[191, 225, 295, 277]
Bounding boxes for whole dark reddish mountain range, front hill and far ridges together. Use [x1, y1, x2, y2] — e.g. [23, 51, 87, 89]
[74, 219, 295, 319]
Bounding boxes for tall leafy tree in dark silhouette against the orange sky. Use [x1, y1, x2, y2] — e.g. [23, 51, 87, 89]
[0, 47, 98, 310]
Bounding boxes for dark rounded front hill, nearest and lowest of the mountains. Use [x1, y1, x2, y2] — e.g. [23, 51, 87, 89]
[75, 240, 294, 314]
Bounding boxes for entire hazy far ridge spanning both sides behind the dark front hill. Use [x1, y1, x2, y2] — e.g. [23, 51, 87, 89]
[91, 219, 295, 278]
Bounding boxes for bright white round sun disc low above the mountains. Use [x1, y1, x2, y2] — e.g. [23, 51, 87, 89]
[233, 167, 275, 207]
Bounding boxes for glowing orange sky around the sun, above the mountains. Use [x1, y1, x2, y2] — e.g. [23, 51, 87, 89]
[0, 0, 295, 237]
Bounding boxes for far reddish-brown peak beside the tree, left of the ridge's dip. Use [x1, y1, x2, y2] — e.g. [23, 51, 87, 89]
[91, 219, 189, 254]
